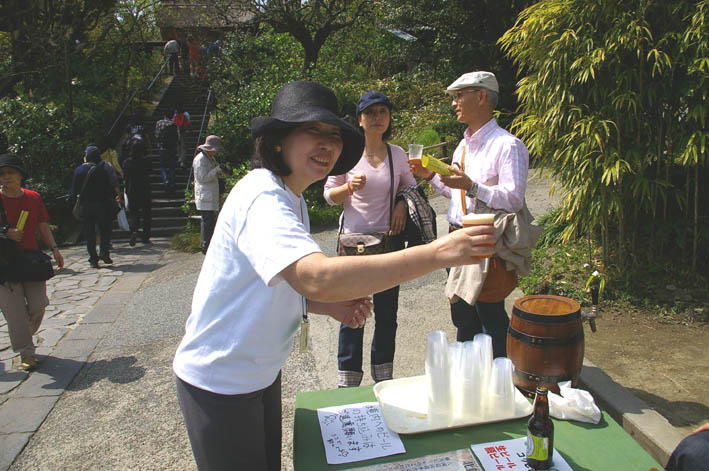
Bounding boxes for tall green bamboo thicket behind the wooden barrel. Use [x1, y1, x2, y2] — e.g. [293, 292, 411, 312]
[499, 0, 709, 271]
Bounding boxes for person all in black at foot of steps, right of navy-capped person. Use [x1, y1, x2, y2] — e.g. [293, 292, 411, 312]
[123, 138, 152, 247]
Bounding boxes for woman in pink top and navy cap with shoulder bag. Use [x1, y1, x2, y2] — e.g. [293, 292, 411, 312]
[323, 91, 416, 387]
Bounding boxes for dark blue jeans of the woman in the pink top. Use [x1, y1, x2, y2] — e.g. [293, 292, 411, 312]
[337, 236, 404, 372]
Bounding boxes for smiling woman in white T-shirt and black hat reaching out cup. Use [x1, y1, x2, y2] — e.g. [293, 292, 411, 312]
[173, 81, 493, 471]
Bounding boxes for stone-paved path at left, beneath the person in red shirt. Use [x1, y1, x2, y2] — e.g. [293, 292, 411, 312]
[0, 239, 167, 470]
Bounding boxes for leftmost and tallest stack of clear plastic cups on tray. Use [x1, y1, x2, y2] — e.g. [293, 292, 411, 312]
[424, 330, 453, 427]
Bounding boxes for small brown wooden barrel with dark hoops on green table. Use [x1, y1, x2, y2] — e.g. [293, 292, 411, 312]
[507, 295, 584, 395]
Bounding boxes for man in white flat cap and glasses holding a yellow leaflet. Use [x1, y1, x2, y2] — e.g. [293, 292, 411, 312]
[412, 71, 529, 357]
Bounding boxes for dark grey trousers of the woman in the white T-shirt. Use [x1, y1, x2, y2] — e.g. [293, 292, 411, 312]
[176, 373, 282, 471]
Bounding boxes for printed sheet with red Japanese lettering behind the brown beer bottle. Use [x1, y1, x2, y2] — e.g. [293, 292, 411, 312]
[470, 437, 573, 471]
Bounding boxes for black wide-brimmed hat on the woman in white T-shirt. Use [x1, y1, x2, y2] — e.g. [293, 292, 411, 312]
[251, 81, 364, 175]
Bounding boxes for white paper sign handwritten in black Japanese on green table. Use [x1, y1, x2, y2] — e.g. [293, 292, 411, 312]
[318, 402, 406, 464]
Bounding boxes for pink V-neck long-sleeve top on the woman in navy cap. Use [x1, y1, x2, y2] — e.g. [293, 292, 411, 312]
[323, 144, 416, 232]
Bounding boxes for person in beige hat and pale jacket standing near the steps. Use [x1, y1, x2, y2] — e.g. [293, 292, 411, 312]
[192, 136, 226, 254]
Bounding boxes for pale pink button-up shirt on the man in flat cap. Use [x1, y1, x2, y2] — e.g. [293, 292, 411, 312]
[431, 118, 529, 226]
